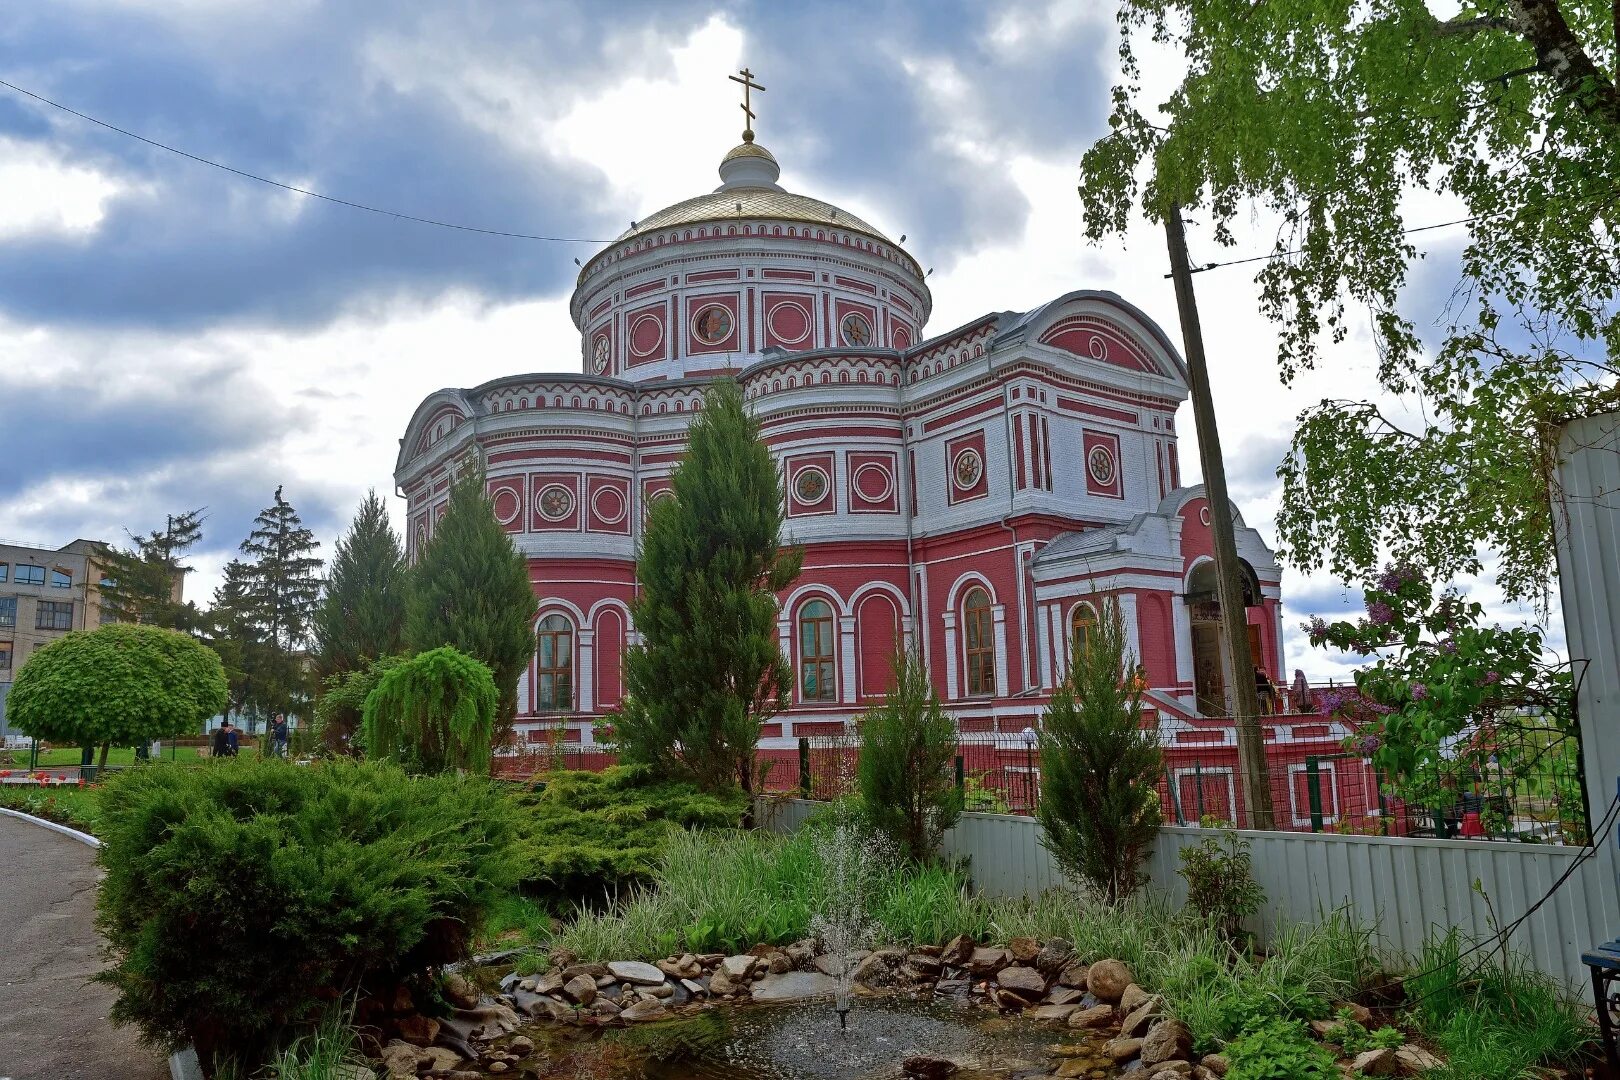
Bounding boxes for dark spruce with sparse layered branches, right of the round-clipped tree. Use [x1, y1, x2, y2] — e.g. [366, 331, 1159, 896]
[240, 486, 321, 730]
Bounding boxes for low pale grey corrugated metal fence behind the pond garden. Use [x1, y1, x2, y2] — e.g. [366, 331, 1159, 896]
[758, 798, 1620, 993]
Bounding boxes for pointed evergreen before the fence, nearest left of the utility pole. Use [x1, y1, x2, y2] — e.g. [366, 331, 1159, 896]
[1037, 607, 1163, 904]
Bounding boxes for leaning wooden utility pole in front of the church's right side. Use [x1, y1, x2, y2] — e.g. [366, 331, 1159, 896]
[1165, 204, 1272, 829]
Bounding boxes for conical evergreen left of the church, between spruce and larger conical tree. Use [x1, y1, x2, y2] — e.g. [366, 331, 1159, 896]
[314, 491, 405, 677]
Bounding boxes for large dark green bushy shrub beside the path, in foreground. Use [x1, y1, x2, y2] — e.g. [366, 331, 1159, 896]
[97, 759, 518, 1072]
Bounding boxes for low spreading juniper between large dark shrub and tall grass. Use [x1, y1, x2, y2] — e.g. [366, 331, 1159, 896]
[517, 766, 745, 900]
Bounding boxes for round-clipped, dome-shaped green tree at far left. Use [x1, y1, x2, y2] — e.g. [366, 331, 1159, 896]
[6, 623, 227, 766]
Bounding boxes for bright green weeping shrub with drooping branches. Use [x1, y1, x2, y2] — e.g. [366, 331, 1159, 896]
[365, 644, 497, 774]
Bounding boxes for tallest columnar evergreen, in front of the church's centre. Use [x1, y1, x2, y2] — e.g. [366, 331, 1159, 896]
[619, 381, 804, 792]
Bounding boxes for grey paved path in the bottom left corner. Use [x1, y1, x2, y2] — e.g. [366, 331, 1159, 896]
[0, 814, 168, 1080]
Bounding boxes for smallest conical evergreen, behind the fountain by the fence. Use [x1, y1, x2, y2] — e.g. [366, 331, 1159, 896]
[857, 653, 962, 860]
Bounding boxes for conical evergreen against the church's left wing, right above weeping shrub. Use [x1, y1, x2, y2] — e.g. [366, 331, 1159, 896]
[405, 468, 538, 746]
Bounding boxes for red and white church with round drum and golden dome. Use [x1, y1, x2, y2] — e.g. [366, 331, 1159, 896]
[395, 124, 1285, 746]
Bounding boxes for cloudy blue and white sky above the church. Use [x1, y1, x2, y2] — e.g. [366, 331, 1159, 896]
[0, 0, 1562, 678]
